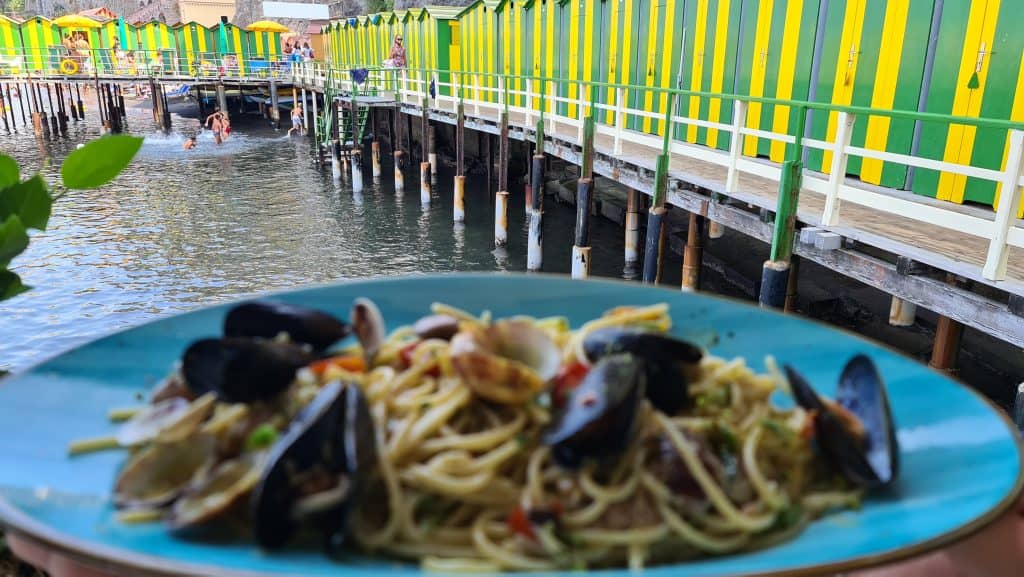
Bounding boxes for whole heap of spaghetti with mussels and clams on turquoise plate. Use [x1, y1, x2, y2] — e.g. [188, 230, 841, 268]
[71, 298, 899, 572]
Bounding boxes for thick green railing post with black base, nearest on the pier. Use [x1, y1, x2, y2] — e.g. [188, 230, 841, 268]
[758, 107, 807, 308]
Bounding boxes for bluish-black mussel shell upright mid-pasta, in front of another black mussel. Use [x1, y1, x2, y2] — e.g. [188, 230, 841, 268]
[544, 355, 647, 468]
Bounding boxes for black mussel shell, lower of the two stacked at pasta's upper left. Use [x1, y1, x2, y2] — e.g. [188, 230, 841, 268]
[181, 337, 315, 403]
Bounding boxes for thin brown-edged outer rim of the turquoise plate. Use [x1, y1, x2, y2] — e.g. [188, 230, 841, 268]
[0, 271, 1024, 577]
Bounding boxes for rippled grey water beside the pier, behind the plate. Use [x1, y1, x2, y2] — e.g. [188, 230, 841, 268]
[0, 102, 663, 370]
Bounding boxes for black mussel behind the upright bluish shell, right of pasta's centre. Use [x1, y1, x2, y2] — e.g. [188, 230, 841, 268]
[583, 327, 703, 415]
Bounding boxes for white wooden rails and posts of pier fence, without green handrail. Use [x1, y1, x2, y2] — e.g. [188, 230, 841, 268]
[323, 69, 1024, 281]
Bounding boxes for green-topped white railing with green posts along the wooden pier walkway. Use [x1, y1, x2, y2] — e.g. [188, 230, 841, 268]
[294, 64, 1024, 281]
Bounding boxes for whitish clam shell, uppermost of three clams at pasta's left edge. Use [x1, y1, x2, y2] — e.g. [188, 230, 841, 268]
[116, 394, 216, 447]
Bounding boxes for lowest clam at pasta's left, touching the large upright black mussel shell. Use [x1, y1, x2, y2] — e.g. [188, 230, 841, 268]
[167, 452, 265, 534]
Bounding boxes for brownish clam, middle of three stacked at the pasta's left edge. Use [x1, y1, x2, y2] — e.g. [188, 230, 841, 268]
[114, 434, 214, 507]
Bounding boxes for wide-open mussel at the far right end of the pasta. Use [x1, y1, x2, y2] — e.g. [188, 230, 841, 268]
[784, 355, 899, 489]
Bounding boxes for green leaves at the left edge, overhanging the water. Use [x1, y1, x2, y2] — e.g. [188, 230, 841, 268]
[0, 136, 142, 300]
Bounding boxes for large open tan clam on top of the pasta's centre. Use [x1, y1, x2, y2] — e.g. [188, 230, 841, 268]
[451, 320, 561, 405]
